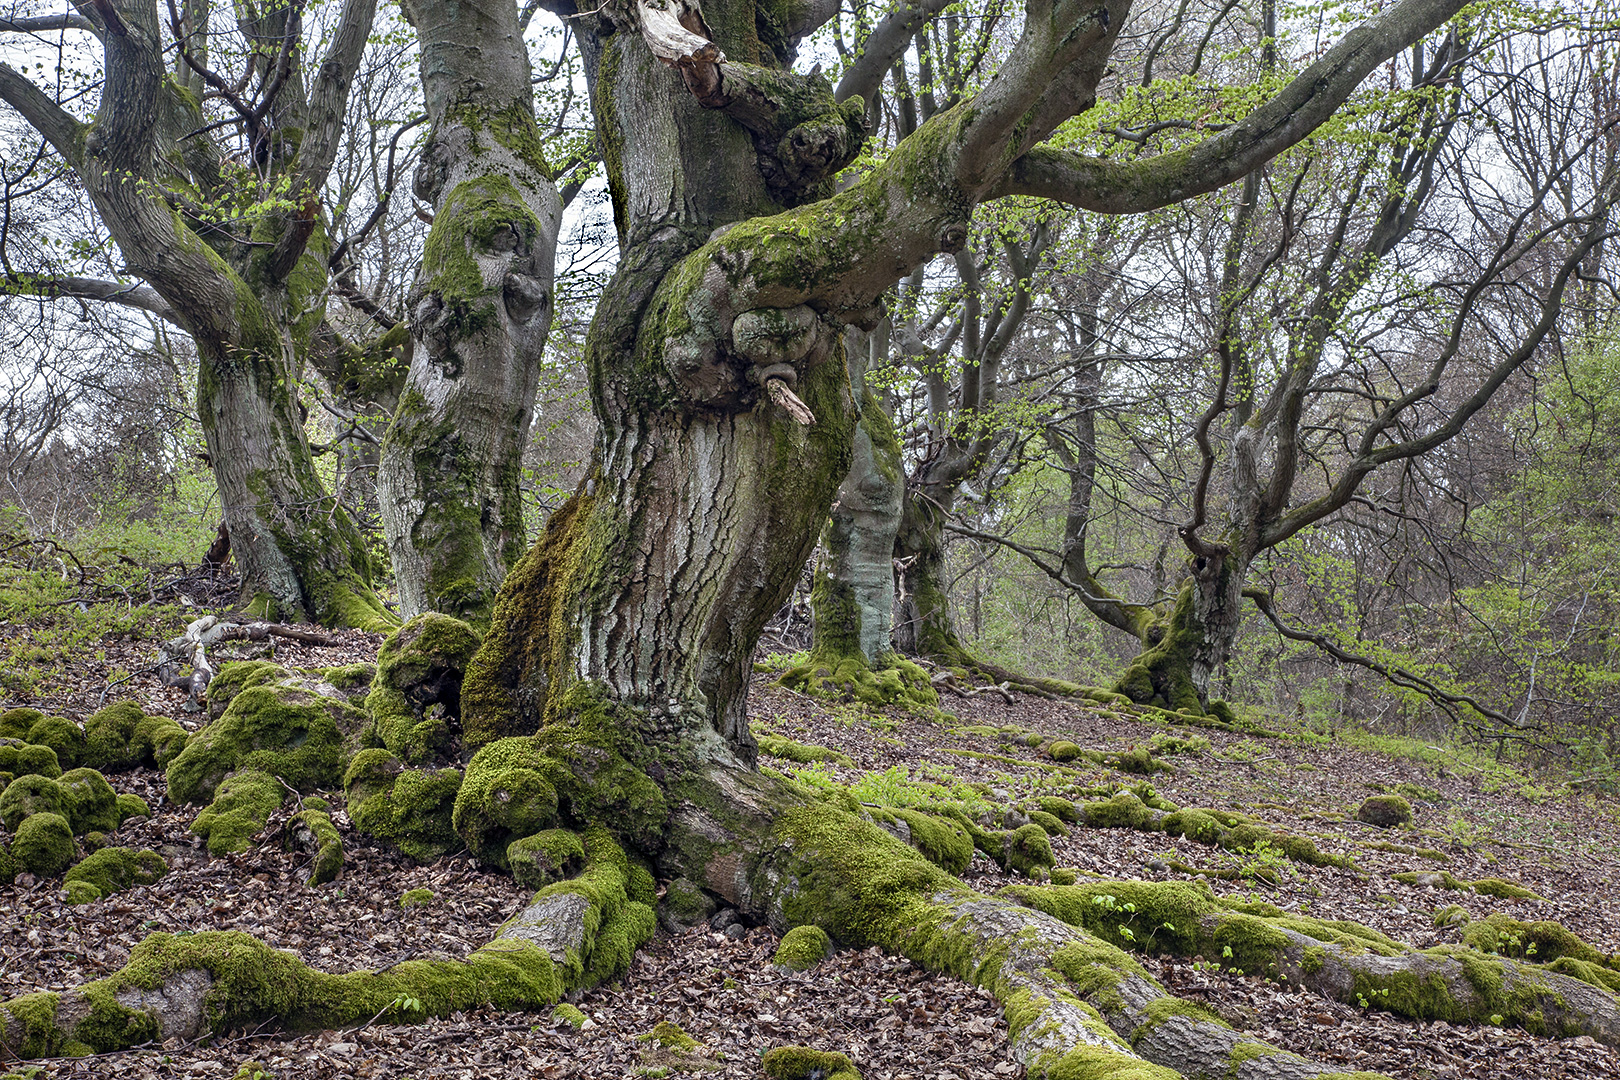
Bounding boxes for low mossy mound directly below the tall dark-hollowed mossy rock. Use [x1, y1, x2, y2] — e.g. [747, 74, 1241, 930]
[343, 750, 465, 863]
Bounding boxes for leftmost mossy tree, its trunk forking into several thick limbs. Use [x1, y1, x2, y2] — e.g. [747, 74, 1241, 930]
[0, 0, 390, 625]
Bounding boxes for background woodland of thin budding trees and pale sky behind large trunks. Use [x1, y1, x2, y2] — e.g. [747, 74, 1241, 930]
[0, 0, 1620, 784]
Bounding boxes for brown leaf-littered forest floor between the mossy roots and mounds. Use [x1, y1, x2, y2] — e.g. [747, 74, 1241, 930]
[0, 623, 1620, 1080]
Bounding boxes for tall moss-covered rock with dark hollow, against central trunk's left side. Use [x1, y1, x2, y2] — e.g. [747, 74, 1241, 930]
[366, 612, 481, 764]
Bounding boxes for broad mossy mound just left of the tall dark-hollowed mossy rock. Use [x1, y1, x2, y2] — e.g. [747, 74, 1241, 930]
[167, 683, 366, 803]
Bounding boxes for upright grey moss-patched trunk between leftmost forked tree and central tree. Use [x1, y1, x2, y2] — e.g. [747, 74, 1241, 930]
[377, 0, 562, 623]
